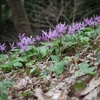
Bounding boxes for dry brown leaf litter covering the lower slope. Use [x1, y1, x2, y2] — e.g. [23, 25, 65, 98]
[0, 35, 100, 100]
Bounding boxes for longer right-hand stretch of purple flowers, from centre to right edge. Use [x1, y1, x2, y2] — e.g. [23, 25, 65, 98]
[40, 16, 100, 38]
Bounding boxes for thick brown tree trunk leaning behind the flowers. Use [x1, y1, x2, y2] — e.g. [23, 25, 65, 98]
[8, 0, 32, 36]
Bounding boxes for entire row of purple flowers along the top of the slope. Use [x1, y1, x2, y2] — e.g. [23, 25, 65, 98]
[0, 16, 100, 52]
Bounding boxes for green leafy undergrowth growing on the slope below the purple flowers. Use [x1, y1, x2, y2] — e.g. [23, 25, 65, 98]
[0, 15, 100, 100]
